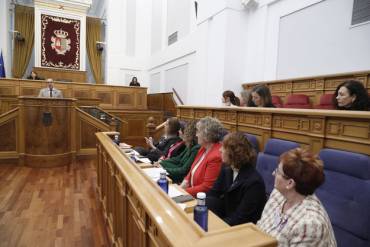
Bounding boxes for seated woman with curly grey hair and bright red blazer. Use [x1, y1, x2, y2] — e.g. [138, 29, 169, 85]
[181, 117, 223, 197]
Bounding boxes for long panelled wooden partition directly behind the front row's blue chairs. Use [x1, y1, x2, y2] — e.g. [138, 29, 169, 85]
[177, 106, 370, 155]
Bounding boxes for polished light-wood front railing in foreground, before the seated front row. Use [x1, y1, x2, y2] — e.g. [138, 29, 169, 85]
[96, 133, 277, 247]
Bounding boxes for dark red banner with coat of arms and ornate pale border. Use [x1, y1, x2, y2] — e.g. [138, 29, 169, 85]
[41, 14, 80, 70]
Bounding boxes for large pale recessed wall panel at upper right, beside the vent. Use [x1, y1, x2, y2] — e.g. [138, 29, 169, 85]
[276, 0, 370, 78]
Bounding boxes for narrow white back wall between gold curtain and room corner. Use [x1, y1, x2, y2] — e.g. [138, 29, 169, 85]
[105, 0, 152, 86]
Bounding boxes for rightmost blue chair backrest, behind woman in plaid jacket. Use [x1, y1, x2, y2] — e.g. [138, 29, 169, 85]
[316, 149, 370, 247]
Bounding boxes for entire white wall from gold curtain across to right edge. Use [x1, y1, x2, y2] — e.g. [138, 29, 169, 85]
[107, 0, 370, 105]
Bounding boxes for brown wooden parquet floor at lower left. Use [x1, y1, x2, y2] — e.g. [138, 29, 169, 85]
[0, 160, 109, 247]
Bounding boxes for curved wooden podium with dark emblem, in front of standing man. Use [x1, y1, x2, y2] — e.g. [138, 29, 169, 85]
[18, 96, 76, 167]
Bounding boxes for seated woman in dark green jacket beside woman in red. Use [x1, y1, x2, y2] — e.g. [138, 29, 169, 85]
[159, 121, 200, 183]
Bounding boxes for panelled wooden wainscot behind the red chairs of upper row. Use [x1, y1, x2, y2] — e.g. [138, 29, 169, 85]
[242, 71, 370, 106]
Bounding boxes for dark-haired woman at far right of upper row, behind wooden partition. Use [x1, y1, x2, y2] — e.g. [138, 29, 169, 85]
[333, 80, 370, 111]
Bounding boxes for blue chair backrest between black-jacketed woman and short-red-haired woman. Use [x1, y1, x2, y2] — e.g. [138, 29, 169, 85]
[256, 139, 299, 195]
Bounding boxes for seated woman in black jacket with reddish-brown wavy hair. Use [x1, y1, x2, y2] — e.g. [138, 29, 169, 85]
[206, 132, 266, 226]
